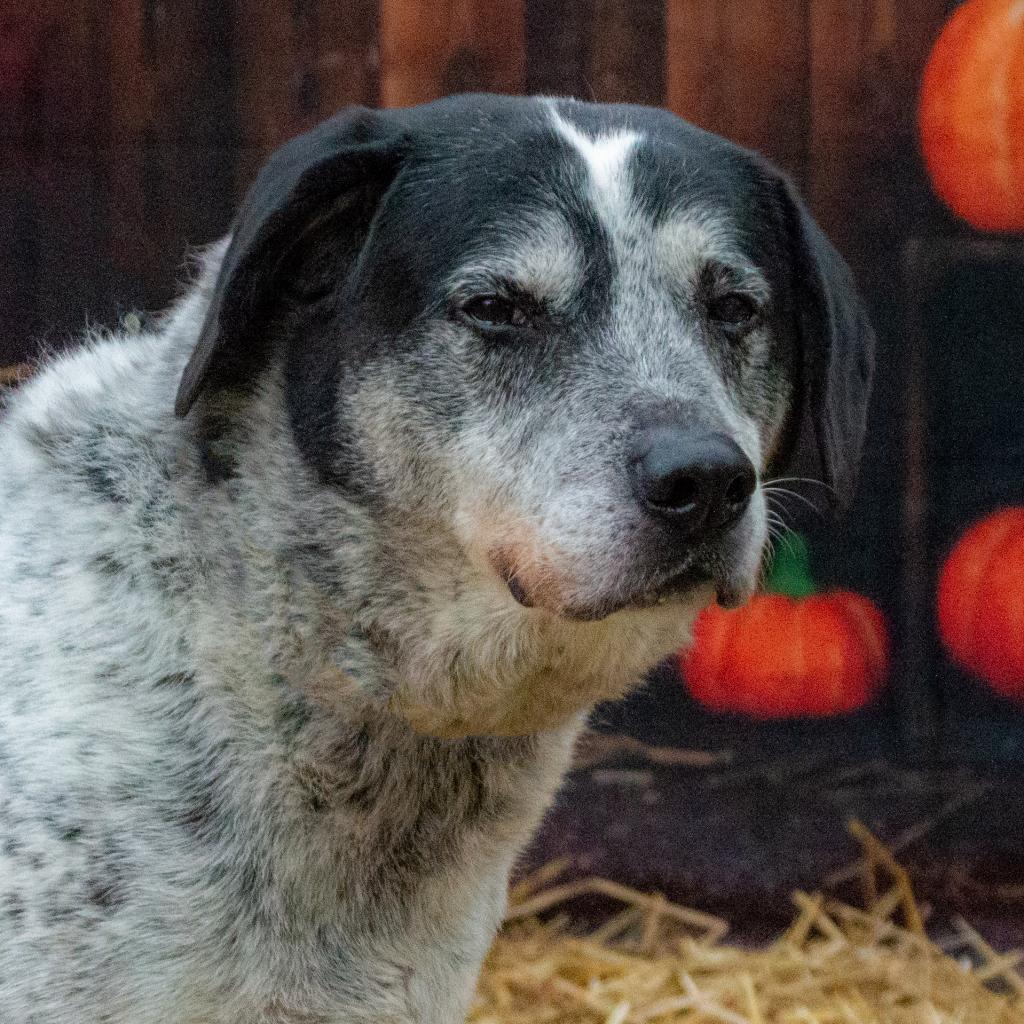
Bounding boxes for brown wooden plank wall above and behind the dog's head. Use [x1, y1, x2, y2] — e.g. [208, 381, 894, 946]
[0, 0, 950, 362]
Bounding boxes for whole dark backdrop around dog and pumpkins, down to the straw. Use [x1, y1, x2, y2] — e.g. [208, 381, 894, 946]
[0, 0, 1024, 909]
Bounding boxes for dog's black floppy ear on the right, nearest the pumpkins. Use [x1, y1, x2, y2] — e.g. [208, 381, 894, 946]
[776, 178, 874, 508]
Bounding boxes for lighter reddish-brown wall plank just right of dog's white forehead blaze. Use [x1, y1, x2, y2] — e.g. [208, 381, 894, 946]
[666, 0, 809, 180]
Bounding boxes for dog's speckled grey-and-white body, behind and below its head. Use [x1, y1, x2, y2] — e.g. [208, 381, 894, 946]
[0, 294, 572, 1024]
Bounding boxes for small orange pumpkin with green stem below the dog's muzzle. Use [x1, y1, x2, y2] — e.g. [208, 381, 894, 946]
[680, 535, 889, 719]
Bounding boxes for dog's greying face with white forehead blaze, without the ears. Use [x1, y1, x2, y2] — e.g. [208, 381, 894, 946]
[353, 112, 796, 618]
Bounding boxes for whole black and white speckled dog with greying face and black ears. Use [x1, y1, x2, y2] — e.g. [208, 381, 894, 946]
[0, 95, 873, 1024]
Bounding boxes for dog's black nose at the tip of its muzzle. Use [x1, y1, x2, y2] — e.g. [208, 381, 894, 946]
[635, 426, 758, 534]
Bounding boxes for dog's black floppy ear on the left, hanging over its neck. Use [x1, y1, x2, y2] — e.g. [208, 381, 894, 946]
[174, 108, 404, 417]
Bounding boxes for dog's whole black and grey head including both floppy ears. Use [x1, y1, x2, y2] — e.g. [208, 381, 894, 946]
[177, 96, 873, 729]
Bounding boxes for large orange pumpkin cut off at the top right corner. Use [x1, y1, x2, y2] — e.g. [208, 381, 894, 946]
[919, 0, 1024, 231]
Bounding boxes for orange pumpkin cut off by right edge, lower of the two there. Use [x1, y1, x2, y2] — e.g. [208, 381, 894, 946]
[938, 508, 1024, 700]
